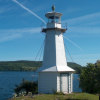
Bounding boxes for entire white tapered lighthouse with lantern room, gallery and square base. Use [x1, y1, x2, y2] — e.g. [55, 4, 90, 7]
[38, 6, 74, 93]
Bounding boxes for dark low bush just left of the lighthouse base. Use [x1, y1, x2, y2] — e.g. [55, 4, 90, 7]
[15, 80, 38, 95]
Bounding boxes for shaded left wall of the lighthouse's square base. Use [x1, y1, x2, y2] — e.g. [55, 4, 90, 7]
[38, 72, 57, 93]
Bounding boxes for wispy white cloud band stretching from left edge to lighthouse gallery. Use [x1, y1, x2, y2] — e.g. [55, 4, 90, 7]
[0, 27, 41, 42]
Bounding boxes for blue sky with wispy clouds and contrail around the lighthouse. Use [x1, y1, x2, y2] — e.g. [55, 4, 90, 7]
[0, 0, 100, 66]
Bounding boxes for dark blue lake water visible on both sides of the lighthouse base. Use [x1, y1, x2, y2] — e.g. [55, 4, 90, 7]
[0, 71, 81, 100]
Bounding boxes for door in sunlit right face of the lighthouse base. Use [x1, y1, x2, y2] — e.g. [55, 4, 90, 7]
[60, 74, 68, 93]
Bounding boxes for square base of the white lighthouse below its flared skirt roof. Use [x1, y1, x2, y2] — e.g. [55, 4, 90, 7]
[38, 72, 73, 94]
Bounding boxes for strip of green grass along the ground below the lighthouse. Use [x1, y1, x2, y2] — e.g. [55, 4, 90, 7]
[10, 93, 99, 100]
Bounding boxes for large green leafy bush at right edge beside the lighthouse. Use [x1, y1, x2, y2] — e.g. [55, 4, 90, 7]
[80, 61, 100, 94]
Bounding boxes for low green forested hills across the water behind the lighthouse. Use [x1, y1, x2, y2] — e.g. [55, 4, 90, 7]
[0, 60, 82, 73]
